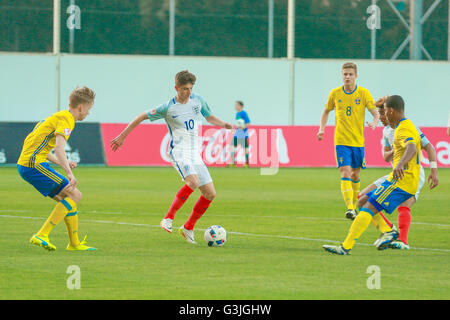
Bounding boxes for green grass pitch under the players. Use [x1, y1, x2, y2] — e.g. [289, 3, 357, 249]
[0, 167, 450, 300]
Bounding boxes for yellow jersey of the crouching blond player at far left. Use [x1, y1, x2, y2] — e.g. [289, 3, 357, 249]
[17, 110, 75, 167]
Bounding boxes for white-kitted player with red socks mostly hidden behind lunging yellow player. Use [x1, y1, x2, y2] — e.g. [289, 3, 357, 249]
[358, 97, 439, 249]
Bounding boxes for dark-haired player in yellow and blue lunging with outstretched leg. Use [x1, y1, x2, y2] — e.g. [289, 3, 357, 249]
[323, 95, 421, 255]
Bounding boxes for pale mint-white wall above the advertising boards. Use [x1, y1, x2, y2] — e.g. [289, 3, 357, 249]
[0, 53, 450, 127]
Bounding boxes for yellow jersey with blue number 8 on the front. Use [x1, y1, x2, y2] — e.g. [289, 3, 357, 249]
[325, 86, 376, 147]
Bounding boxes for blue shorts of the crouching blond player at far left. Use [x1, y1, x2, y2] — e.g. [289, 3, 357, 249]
[17, 162, 69, 198]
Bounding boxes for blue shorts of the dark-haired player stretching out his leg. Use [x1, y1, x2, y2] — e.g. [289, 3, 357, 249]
[367, 180, 414, 214]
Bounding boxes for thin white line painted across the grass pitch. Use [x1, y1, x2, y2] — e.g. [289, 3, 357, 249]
[0, 215, 450, 252]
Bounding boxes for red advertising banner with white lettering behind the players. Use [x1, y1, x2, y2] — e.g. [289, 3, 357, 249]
[101, 124, 450, 168]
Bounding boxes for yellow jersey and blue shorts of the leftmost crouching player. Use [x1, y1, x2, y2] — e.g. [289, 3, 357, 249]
[17, 110, 75, 197]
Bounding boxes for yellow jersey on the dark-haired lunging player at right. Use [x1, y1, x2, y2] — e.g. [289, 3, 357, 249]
[388, 119, 421, 194]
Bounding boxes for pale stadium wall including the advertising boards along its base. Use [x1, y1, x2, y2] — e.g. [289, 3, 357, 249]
[0, 53, 450, 167]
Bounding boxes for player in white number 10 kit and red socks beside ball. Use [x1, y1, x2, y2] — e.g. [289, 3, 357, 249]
[111, 70, 233, 243]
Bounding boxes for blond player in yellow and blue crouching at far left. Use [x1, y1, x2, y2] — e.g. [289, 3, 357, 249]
[17, 87, 97, 251]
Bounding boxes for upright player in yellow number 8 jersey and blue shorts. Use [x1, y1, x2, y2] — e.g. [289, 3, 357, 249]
[317, 62, 381, 220]
